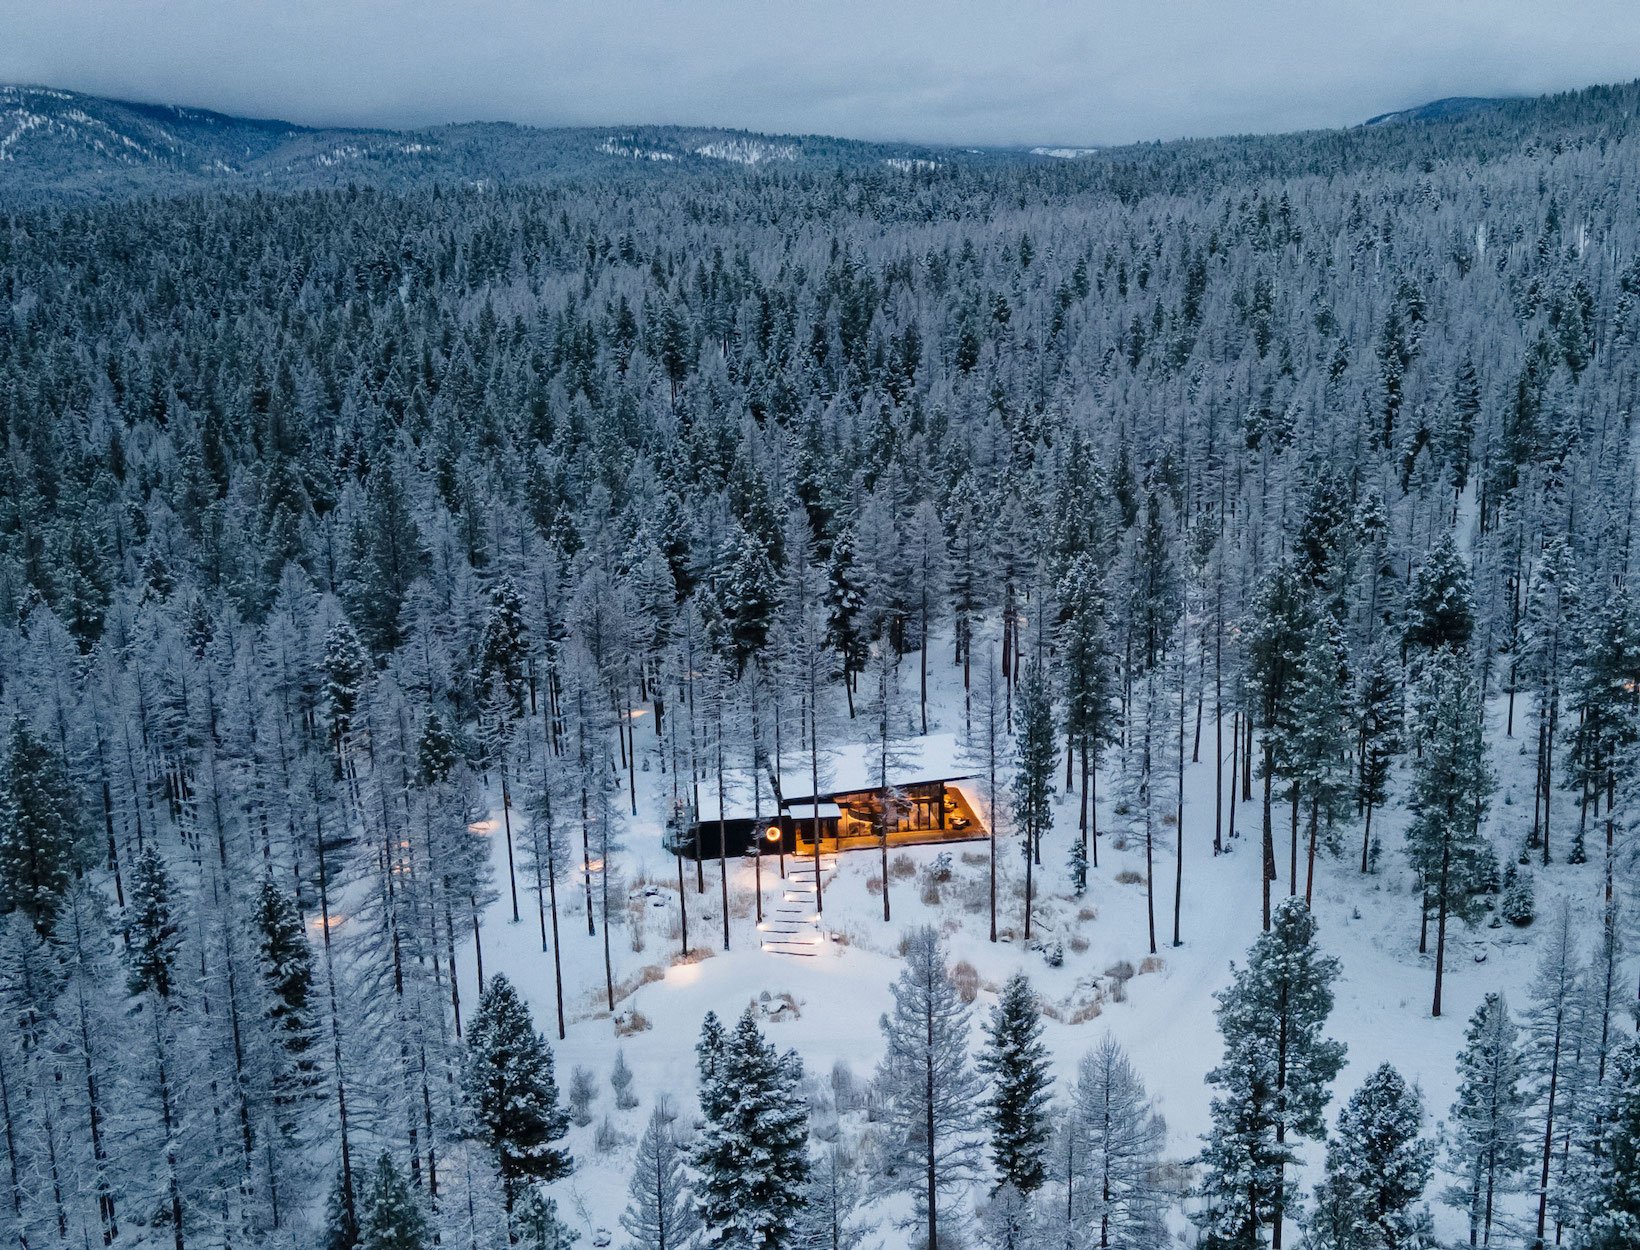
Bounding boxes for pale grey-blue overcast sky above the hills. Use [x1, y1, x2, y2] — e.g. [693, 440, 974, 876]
[0, 0, 1640, 144]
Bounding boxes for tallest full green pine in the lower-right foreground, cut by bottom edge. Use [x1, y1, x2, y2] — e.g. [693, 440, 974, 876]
[1197, 899, 1345, 1250]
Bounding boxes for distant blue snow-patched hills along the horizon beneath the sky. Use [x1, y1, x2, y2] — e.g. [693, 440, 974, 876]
[0, 76, 1640, 204]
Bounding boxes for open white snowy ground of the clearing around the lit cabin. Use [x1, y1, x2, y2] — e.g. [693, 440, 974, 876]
[459, 626, 1599, 1250]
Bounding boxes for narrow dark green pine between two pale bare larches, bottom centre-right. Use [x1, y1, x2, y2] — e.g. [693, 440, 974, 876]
[977, 973, 1053, 1194]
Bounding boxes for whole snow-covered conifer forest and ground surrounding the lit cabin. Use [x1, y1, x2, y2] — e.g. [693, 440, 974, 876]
[0, 75, 1640, 1250]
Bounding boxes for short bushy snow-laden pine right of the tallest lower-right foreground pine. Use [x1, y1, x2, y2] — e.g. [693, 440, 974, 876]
[1305, 1063, 1435, 1250]
